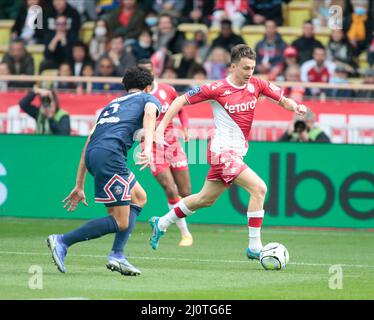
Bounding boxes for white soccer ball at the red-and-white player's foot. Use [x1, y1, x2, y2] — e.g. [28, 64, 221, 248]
[260, 242, 290, 270]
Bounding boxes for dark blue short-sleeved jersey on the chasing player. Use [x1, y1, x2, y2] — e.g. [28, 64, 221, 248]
[87, 91, 162, 158]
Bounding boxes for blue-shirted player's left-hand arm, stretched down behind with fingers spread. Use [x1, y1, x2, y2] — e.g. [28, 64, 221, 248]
[62, 136, 91, 212]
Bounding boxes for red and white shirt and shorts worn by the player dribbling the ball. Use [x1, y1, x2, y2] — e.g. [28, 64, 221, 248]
[184, 77, 283, 186]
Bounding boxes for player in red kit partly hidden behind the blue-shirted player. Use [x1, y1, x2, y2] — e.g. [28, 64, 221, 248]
[137, 59, 193, 247]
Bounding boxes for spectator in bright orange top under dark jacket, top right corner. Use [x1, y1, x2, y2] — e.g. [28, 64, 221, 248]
[343, 0, 374, 56]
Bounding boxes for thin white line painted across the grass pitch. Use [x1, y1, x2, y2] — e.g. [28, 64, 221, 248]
[0, 251, 374, 268]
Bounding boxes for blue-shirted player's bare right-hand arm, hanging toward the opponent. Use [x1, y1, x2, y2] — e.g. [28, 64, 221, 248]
[136, 102, 157, 170]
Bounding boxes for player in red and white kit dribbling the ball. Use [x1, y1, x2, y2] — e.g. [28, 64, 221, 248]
[150, 44, 307, 259]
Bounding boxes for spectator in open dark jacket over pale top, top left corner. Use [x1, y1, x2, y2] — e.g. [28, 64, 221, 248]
[11, 0, 43, 45]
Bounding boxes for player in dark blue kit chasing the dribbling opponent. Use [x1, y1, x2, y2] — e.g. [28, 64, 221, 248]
[47, 67, 161, 276]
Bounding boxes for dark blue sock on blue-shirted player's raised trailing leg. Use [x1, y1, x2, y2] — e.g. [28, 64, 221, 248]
[62, 216, 119, 247]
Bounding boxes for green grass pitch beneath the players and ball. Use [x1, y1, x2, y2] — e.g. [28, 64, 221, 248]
[0, 218, 374, 300]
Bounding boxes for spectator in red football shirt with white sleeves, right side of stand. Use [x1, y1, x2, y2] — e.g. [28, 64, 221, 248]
[301, 47, 335, 96]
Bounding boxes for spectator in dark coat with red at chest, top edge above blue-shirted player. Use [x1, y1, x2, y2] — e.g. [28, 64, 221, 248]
[105, 0, 145, 39]
